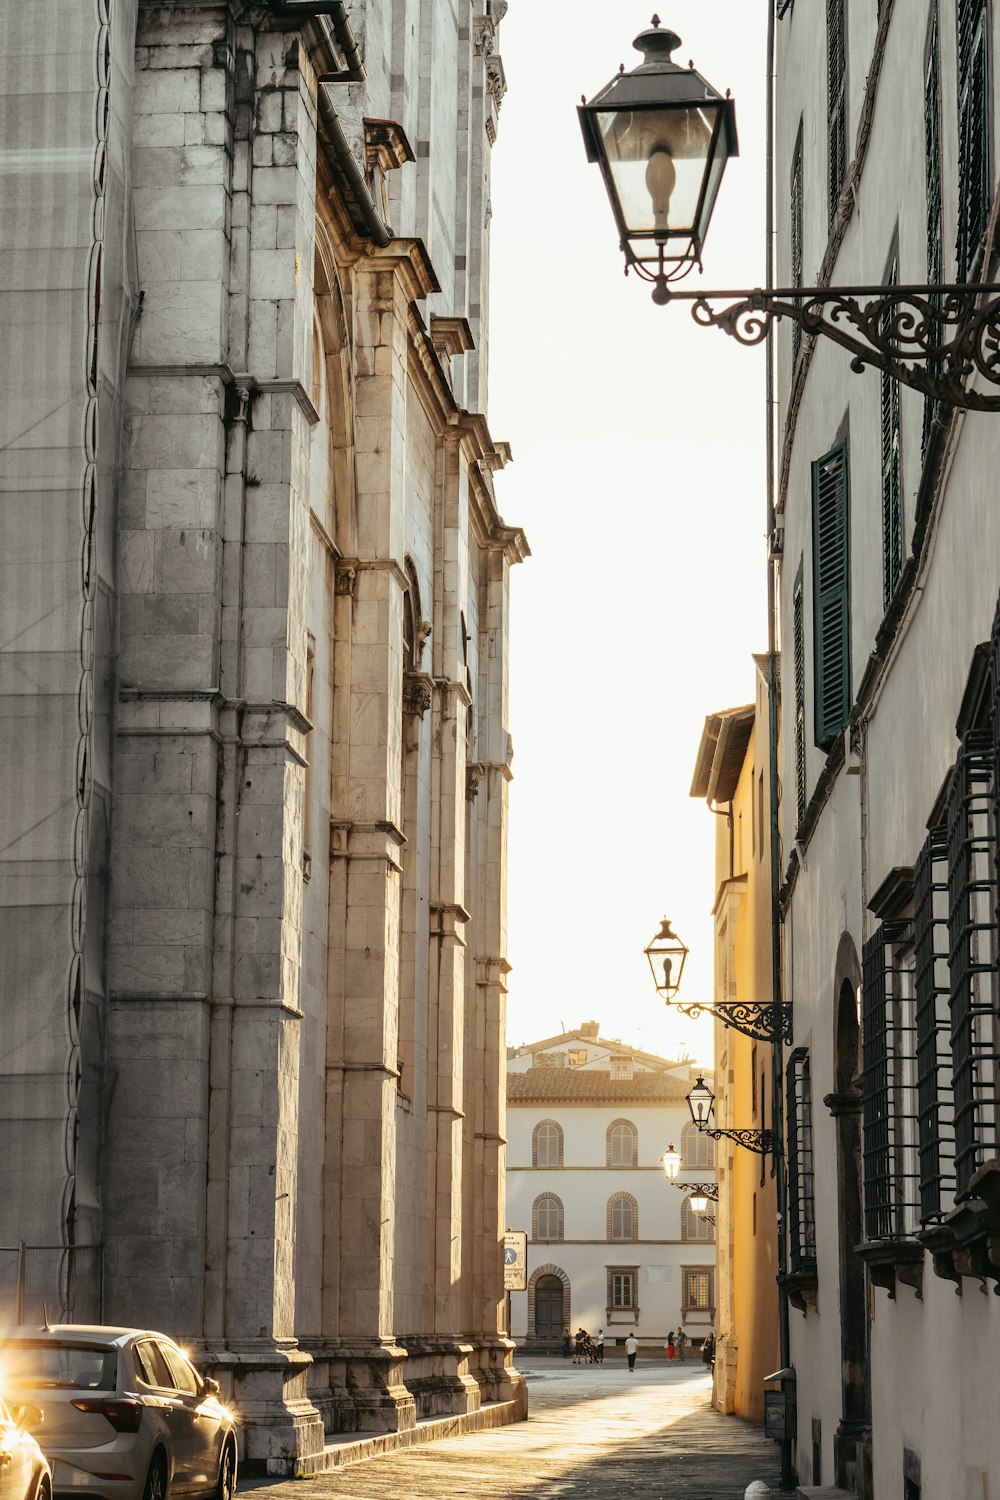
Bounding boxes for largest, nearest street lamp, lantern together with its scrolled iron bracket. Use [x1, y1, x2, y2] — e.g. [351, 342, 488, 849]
[579, 17, 1000, 411]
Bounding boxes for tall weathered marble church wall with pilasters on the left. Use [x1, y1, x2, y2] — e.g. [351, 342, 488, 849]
[0, 0, 528, 1472]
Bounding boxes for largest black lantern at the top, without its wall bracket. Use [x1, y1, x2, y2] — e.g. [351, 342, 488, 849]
[577, 15, 739, 302]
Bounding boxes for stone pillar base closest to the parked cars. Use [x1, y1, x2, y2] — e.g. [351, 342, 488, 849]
[192, 1338, 324, 1476]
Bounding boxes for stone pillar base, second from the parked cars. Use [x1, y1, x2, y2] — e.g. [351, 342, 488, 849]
[301, 1338, 417, 1433]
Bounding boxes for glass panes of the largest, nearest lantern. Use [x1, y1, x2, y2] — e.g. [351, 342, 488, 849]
[597, 104, 724, 236]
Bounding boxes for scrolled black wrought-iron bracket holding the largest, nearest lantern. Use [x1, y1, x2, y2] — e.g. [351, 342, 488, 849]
[654, 282, 1000, 411]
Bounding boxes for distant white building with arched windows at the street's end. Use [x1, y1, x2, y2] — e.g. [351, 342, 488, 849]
[507, 1022, 715, 1347]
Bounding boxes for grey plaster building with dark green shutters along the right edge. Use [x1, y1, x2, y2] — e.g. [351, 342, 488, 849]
[775, 0, 1000, 1500]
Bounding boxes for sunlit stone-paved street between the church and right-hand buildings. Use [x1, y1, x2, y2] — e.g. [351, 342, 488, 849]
[240, 1355, 778, 1500]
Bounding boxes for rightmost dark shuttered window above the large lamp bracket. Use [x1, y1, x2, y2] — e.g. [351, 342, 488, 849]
[955, 0, 993, 282]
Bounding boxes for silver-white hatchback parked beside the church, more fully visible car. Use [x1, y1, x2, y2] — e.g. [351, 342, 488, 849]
[0, 1325, 237, 1500]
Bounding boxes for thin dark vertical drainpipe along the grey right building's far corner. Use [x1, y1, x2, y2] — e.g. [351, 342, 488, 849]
[765, 0, 795, 1490]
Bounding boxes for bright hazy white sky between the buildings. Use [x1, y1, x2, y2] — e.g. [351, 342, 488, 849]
[489, 0, 769, 1061]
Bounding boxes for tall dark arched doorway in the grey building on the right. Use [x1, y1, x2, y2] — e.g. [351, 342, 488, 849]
[826, 933, 871, 1496]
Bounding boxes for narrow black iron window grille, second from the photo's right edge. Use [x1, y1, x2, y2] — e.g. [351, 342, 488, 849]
[913, 827, 955, 1224]
